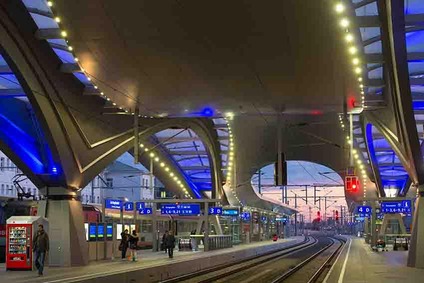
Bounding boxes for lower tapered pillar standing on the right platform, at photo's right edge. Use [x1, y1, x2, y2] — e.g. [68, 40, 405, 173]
[408, 194, 424, 268]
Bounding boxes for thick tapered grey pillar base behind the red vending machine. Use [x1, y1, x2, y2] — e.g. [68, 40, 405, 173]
[37, 187, 88, 266]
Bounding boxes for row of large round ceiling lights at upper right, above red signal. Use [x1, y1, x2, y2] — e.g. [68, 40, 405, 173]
[334, 2, 365, 108]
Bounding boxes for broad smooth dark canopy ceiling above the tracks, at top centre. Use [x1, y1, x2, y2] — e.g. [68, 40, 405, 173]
[23, 0, 355, 117]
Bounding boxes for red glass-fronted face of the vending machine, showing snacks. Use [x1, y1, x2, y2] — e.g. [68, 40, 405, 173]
[6, 224, 32, 269]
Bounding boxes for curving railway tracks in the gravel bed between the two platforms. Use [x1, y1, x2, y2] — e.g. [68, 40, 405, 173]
[163, 236, 345, 283]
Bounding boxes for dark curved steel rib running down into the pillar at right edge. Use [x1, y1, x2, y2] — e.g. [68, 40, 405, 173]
[377, 0, 424, 268]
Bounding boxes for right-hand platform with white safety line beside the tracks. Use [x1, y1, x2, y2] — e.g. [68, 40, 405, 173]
[323, 237, 424, 283]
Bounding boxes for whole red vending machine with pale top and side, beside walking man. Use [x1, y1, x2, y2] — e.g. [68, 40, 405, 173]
[6, 216, 48, 270]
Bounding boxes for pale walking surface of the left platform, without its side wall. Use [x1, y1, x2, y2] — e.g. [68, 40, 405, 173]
[0, 237, 304, 283]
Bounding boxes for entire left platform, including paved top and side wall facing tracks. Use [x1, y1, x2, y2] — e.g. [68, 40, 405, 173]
[0, 236, 304, 283]
